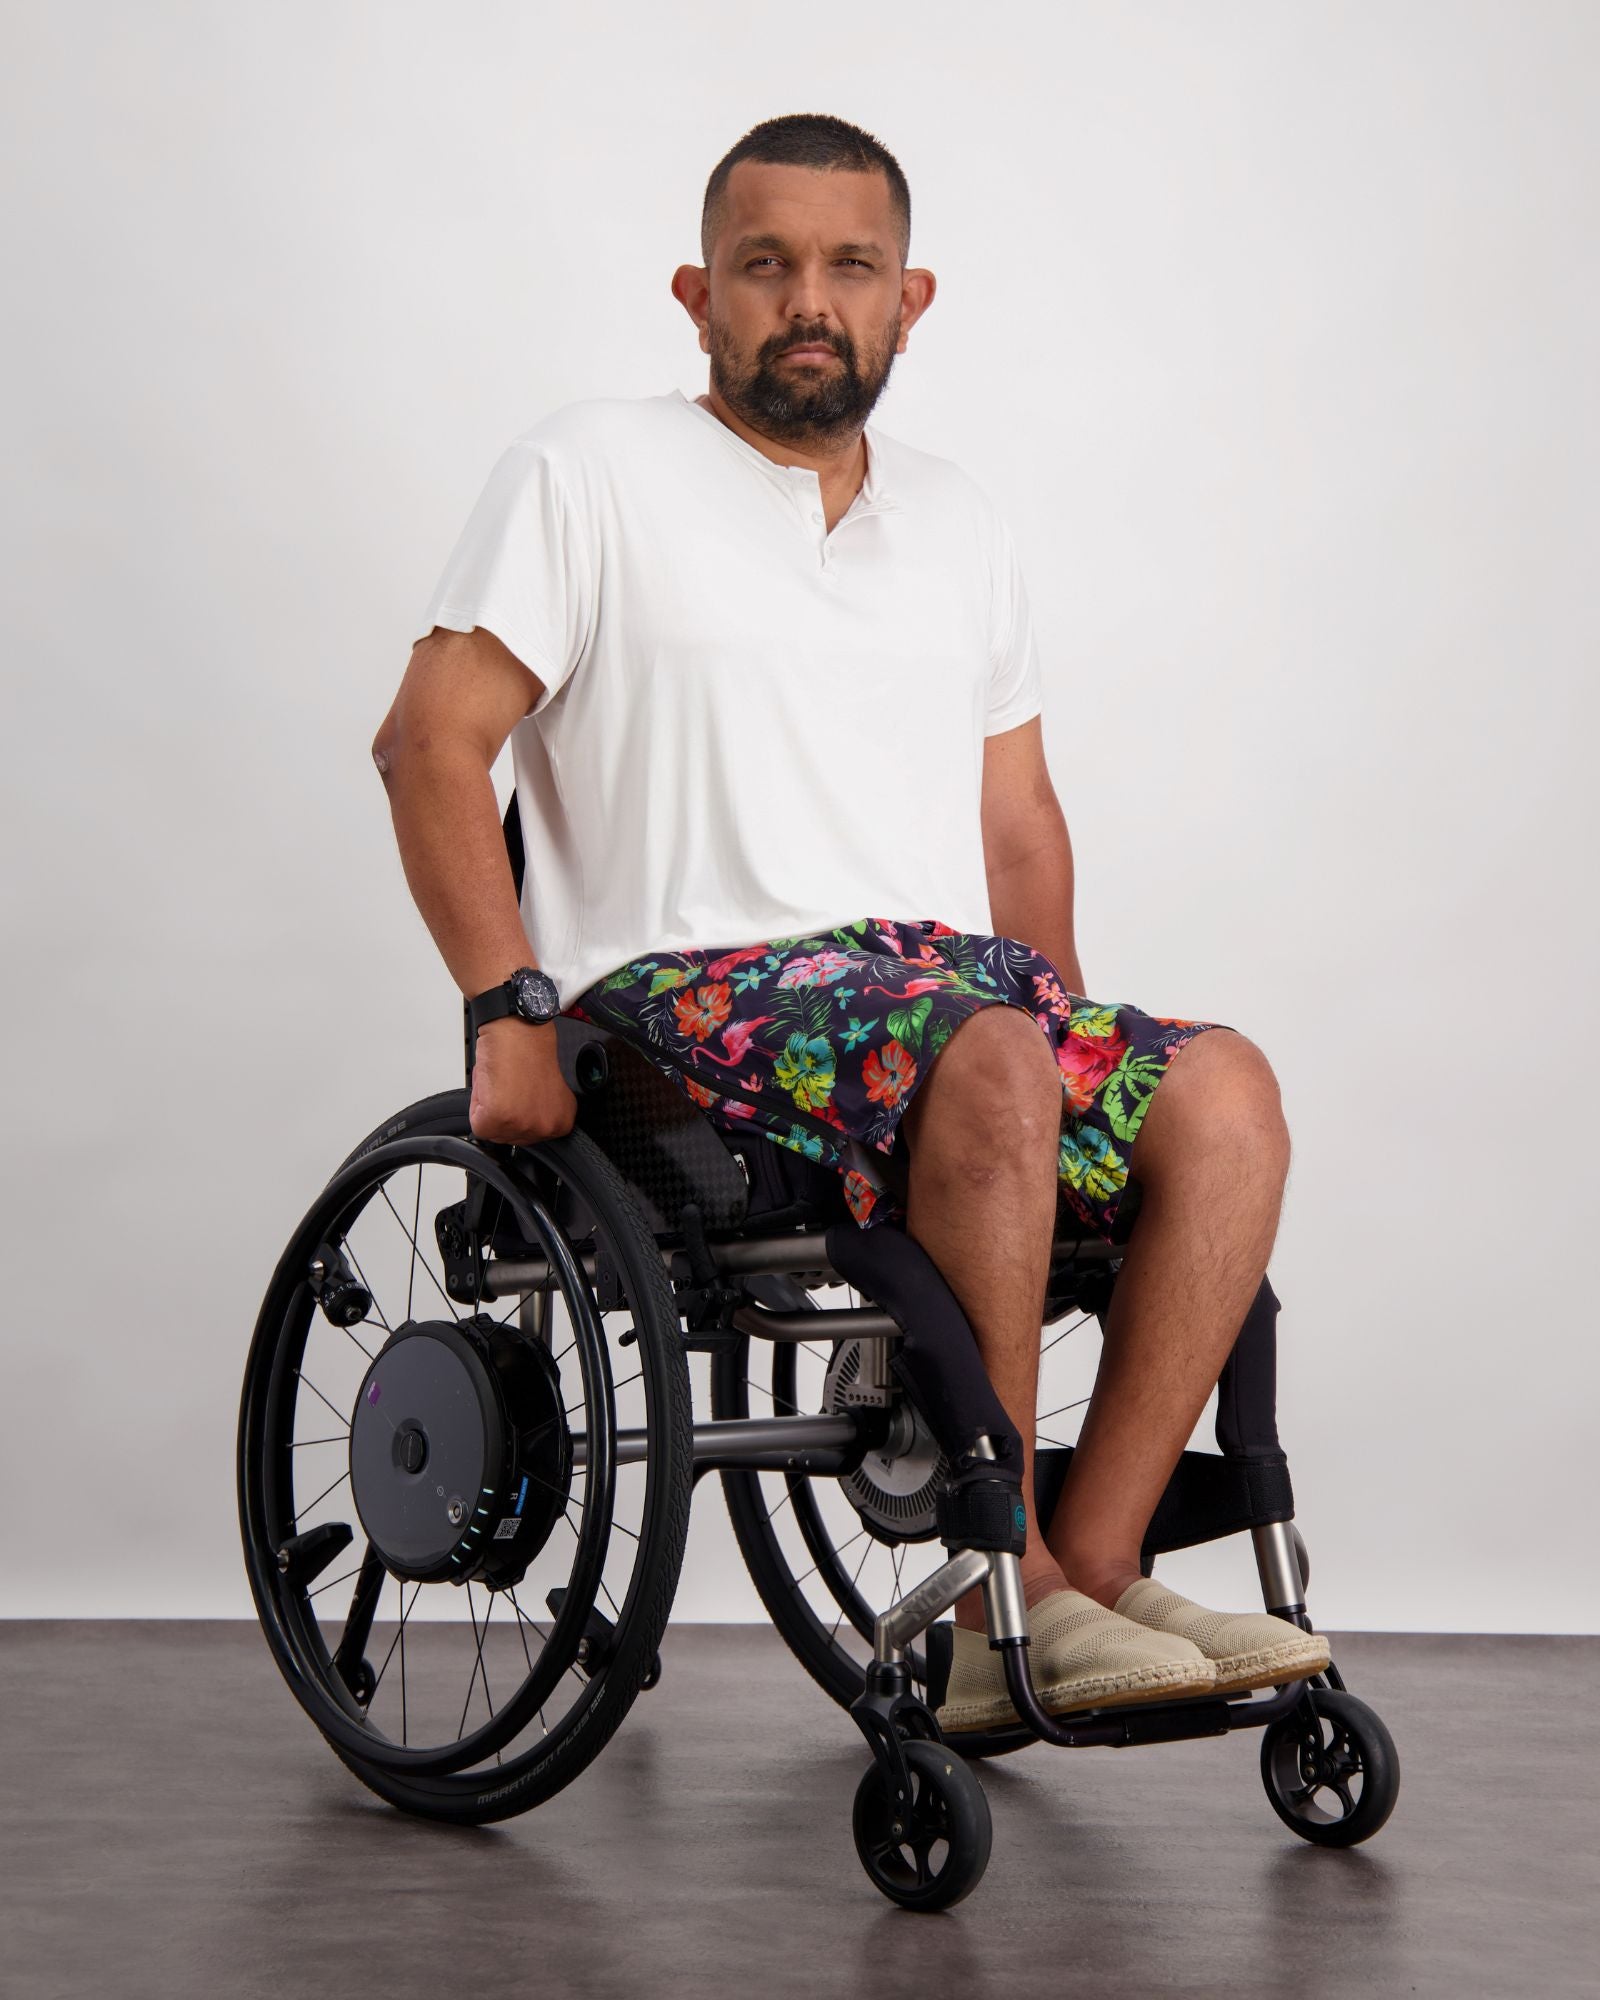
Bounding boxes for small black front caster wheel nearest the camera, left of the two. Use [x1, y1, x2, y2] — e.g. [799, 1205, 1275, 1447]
[850, 1738, 994, 1910]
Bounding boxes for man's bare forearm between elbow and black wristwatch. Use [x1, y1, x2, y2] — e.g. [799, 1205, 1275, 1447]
[380, 740, 536, 996]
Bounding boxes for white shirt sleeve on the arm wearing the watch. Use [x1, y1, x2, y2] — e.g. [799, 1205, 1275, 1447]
[418, 438, 592, 714]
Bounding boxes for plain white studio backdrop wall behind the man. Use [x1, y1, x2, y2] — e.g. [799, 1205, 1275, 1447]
[0, 0, 1600, 1632]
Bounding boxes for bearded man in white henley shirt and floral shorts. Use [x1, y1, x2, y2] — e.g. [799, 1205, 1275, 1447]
[374, 118, 1328, 1732]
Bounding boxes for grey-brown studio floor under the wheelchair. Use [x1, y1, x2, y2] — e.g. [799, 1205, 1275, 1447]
[0, 1622, 1600, 2000]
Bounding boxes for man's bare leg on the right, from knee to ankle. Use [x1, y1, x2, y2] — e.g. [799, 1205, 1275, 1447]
[1050, 1030, 1288, 1604]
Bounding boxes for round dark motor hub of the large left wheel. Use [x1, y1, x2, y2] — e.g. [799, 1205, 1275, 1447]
[350, 1314, 572, 1590]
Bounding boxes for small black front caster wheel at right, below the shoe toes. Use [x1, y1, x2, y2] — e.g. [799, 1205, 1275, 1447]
[1262, 1688, 1400, 1848]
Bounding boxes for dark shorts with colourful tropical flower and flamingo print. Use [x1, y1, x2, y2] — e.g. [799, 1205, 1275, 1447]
[564, 916, 1224, 1240]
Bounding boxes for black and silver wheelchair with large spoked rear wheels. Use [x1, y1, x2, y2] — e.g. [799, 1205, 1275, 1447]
[238, 810, 1400, 1910]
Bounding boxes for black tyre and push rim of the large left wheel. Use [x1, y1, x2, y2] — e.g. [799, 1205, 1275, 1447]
[238, 1090, 692, 1824]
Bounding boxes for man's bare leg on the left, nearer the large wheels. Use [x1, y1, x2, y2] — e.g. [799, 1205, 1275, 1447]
[890, 1006, 1072, 1630]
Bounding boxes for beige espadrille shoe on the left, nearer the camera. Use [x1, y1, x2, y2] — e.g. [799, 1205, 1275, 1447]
[936, 1590, 1216, 1734]
